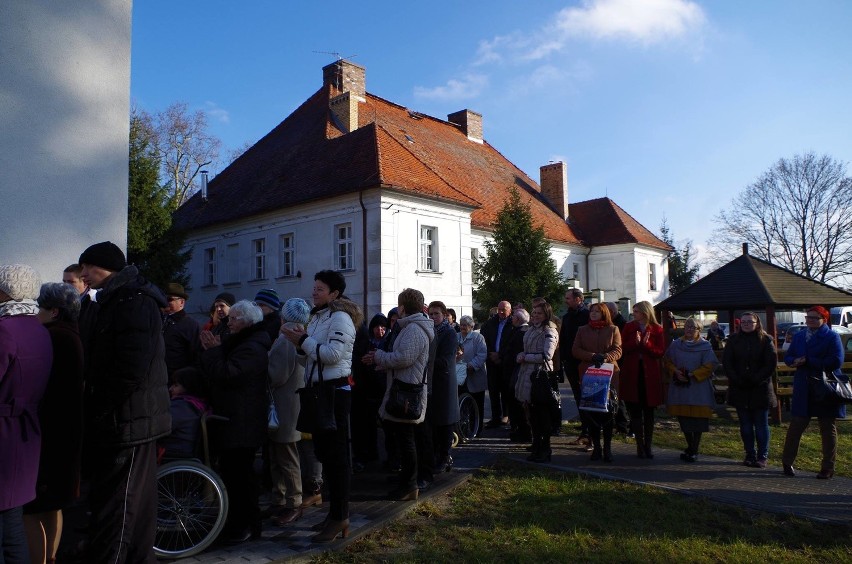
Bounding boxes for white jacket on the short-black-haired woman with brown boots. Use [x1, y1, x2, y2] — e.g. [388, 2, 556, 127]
[299, 298, 363, 383]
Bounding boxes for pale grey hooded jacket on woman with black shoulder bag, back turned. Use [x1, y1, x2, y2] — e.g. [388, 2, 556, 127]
[375, 313, 435, 423]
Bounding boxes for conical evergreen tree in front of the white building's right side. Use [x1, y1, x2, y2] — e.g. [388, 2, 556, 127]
[473, 188, 566, 312]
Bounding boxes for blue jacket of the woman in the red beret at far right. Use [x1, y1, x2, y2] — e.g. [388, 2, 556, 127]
[784, 325, 846, 417]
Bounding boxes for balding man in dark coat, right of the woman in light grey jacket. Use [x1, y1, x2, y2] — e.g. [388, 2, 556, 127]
[481, 301, 512, 429]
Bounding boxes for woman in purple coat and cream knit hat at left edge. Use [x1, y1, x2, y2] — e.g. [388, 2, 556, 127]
[0, 264, 52, 562]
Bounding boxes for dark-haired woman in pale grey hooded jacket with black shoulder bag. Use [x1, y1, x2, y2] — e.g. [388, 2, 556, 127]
[367, 288, 435, 501]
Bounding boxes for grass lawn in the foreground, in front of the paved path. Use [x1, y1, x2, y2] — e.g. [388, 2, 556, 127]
[312, 461, 852, 563]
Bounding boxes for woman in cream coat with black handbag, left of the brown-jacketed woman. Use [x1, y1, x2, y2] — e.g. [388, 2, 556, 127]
[515, 302, 559, 462]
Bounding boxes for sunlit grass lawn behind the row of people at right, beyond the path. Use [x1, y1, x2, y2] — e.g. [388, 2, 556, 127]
[616, 406, 852, 477]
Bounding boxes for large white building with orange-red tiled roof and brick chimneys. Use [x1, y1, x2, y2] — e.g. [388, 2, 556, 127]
[175, 61, 669, 318]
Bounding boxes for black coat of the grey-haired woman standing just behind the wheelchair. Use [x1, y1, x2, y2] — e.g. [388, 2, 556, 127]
[201, 323, 272, 448]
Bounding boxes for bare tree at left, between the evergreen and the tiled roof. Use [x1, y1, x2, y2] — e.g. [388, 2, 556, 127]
[153, 102, 222, 209]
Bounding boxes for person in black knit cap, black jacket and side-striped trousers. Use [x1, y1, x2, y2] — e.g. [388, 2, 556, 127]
[79, 241, 171, 563]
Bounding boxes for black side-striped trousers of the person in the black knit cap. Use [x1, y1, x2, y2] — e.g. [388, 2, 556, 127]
[85, 441, 157, 563]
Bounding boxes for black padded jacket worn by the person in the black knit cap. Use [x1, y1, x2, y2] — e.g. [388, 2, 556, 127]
[84, 266, 171, 448]
